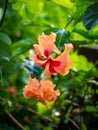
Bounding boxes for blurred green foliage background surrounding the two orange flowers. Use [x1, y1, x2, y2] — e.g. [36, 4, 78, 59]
[0, 0, 98, 130]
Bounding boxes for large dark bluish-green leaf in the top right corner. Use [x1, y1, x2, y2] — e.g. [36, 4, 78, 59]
[83, 2, 98, 30]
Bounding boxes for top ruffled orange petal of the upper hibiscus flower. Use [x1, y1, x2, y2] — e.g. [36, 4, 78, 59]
[34, 33, 60, 57]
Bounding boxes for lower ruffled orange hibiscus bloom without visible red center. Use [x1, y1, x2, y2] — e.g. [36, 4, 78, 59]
[23, 77, 60, 107]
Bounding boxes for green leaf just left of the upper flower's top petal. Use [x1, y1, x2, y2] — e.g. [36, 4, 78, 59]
[11, 39, 32, 58]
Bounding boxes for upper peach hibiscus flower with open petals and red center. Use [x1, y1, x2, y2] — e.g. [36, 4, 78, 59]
[31, 33, 73, 77]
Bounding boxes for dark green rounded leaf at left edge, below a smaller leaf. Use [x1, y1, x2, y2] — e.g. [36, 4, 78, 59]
[0, 40, 12, 60]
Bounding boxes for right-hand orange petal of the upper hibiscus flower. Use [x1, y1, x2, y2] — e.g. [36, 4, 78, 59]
[54, 43, 73, 75]
